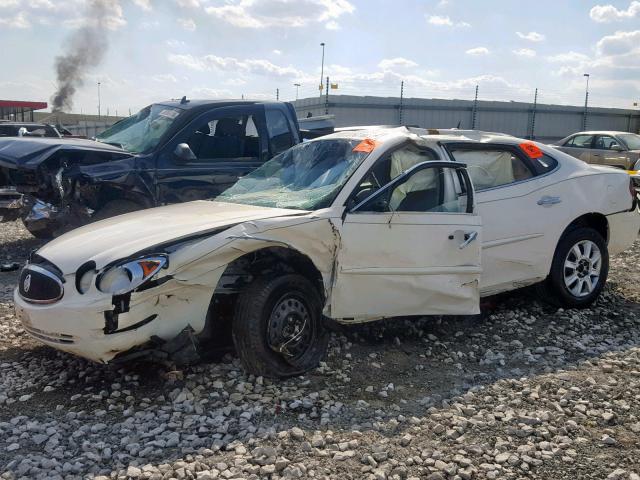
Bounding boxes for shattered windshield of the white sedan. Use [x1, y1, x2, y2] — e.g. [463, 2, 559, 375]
[216, 138, 371, 210]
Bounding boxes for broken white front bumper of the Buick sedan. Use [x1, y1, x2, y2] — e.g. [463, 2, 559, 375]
[14, 280, 212, 363]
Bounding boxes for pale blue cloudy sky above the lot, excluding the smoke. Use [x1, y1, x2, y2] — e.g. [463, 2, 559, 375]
[0, 0, 640, 115]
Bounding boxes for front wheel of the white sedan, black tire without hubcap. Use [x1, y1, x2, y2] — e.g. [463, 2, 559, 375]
[231, 274, 329, 377]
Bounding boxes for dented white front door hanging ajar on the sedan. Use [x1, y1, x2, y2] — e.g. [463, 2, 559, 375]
[331, 146, 481, 321]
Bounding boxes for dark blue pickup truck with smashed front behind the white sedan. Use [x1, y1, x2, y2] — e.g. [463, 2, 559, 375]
[0, 98, 308, 238]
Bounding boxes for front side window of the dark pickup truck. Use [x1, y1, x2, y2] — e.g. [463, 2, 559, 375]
[187, 115, 260, 161]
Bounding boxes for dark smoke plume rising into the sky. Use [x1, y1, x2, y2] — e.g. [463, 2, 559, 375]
[51, 0, 119, 112]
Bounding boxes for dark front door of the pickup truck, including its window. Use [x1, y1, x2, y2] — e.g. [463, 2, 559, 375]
[157, 107, 268, 203]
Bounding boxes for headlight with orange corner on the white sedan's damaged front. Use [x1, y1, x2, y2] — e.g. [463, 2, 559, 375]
[96, 255, 168, 295]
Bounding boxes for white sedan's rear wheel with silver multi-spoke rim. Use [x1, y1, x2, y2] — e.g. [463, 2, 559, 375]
[539, 227, 609, 308]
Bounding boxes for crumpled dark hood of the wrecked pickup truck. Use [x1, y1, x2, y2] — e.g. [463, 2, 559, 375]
[0, 137, 133, 168]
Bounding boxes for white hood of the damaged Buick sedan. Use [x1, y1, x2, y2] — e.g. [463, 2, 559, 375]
[37, 200, 308, 275]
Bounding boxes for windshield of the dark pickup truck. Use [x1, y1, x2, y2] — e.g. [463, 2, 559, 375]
[96, 105, 181, 153]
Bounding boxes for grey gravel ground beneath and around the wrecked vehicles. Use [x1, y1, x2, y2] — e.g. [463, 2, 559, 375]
[0, 218, 640, 480]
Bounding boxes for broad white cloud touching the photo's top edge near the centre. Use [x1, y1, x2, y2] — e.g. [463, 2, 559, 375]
[205, 0, 355, 30]
